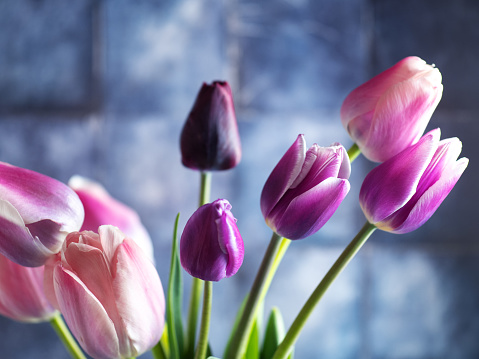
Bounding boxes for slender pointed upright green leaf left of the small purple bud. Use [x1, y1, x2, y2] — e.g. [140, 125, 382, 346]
[166, 213, 184, 359]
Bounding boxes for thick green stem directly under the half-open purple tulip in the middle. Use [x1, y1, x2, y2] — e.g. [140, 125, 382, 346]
[225, 233, 282, 359]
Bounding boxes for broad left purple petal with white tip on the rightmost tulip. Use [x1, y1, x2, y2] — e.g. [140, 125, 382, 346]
[359, 129, 440, 224]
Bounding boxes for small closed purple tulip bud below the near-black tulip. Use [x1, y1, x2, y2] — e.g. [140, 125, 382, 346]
[180, 199, 244, 282]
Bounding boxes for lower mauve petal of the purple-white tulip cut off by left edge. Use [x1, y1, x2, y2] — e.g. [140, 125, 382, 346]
[0, 200, 59, 267]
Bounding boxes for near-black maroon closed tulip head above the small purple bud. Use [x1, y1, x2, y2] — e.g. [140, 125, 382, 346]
[180, 81, 241, 171]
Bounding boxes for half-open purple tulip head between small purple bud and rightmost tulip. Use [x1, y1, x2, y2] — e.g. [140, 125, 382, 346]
[261, 135, 351, 239]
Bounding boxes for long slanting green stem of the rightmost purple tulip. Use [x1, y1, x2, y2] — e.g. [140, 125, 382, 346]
[273, 222, 376, 359]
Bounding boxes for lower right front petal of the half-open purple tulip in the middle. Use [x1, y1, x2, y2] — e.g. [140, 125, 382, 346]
[272, 178, 350, 239]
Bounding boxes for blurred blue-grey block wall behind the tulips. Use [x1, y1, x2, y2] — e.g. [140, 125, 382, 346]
[0, 0, 479, 359]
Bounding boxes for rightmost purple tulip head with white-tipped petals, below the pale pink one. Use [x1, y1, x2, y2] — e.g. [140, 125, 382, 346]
[359, 129, 469, 233]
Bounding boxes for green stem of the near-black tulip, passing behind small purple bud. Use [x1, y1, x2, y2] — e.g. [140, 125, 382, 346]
[185, 172, 211, 358]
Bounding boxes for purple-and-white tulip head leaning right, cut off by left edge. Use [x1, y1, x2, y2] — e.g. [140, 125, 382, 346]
[0, 162, 84, 267]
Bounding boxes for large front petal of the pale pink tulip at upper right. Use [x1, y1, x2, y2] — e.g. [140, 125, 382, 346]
[364, 77, 442, 162]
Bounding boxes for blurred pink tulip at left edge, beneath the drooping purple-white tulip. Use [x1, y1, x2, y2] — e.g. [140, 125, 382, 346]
[0, 254, 57, 323]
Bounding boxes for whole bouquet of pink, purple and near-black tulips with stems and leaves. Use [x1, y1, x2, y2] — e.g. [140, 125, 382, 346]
[0, 57, 468, 359]
